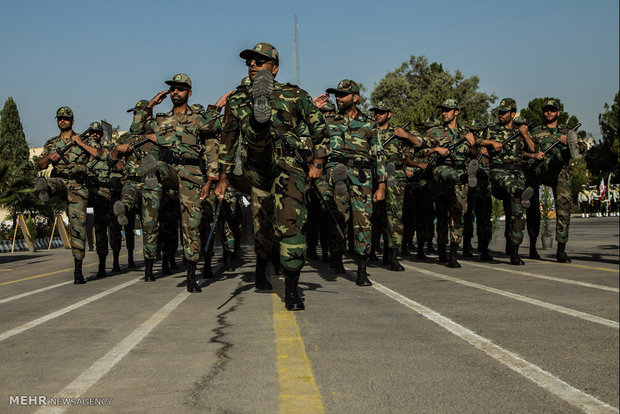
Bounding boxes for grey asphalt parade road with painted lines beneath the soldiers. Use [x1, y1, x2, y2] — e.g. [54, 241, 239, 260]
[0, 217, 619, 413]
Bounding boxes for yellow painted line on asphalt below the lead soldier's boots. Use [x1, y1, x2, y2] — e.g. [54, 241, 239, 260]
[271, 277, 325, 414]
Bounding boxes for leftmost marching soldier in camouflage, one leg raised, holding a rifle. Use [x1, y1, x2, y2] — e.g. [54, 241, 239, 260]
[35, 106, 106, 284]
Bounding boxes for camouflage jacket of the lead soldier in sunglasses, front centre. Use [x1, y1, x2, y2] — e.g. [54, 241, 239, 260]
[219, 82, 329, 174]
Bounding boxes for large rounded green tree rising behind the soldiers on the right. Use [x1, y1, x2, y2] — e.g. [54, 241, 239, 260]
[370, 55, 497, 129]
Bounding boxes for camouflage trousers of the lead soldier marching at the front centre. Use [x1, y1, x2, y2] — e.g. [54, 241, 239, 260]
[251, 169, 308, 271]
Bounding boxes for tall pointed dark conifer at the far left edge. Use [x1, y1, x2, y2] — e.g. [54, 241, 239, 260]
[0, 97, 36, 224]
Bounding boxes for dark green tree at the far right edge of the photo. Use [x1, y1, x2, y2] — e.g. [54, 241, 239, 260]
[586, 92, 620, 182]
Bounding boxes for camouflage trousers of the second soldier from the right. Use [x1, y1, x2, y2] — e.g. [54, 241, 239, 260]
[489, 168, 525, 246]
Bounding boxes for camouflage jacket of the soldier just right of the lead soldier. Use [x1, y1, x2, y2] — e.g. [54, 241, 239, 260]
[326, 114, 387, 185]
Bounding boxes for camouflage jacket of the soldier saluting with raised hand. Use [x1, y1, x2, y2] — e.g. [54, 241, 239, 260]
[129, 106, 217, 178]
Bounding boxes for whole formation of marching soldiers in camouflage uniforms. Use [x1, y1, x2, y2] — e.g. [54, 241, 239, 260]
[36, 43, 578, 311]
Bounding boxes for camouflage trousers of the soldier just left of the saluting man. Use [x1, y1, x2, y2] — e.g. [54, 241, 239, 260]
[121, 181, 162, 259]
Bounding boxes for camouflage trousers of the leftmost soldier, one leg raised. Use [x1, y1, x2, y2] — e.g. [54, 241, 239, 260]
[48, 177, 88, 260]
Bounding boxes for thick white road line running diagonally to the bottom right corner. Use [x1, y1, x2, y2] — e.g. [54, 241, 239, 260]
[372, 281, 618, 413]
